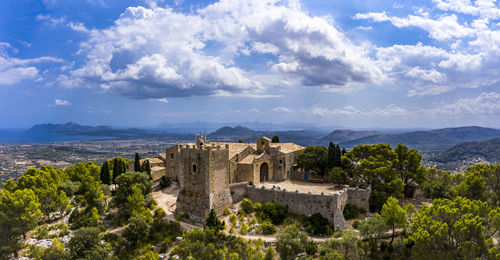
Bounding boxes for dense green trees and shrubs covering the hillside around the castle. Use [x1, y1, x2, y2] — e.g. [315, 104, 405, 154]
[0, 144, 500, 259]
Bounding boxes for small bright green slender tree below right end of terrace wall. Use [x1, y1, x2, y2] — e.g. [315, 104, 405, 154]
[380, 197, 408, 244]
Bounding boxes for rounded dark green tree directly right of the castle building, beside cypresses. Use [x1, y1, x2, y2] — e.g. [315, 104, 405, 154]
[297, 146, 328, 175]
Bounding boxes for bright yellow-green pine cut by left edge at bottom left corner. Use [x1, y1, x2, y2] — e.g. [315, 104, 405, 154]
[0, 189, 42, 256]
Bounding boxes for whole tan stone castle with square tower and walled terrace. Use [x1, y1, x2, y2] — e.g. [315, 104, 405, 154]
[160, 137, 370, 229]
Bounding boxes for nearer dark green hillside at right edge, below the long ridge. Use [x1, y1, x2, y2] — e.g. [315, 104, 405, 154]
[431, 137, 500, 163]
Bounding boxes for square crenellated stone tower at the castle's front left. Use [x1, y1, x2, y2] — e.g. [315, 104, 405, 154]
[176, 139, 232, 222]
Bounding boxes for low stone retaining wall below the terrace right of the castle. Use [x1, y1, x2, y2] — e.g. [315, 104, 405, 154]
[246, 186, 347, 230]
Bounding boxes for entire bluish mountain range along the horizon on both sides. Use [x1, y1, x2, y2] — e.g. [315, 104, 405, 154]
[29, 122, 500, 151]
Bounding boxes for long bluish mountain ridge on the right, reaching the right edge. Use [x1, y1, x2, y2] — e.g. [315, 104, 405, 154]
[340, 126, 500, 151]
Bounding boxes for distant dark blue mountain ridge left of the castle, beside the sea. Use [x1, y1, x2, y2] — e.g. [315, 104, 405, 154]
[28, 122, 193, 141]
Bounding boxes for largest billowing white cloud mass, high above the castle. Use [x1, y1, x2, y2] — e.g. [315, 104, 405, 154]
[68, 0, 383, 98]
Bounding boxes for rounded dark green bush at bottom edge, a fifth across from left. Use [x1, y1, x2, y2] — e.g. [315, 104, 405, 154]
[68, 227, 111, 260]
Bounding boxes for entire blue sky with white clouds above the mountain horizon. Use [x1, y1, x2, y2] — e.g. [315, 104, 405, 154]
[0, 0, 500, 128]
